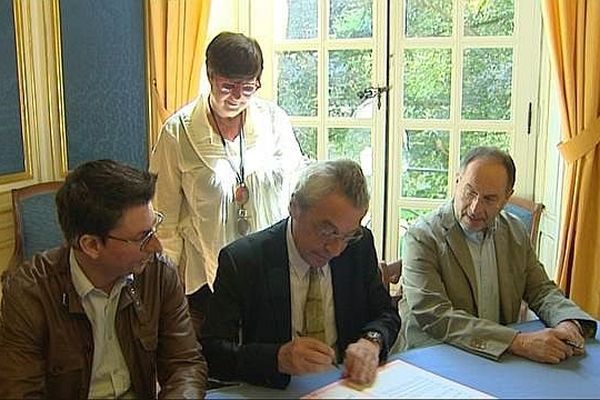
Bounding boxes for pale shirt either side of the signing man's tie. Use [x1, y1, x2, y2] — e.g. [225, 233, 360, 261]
[286, 218, 337, 348]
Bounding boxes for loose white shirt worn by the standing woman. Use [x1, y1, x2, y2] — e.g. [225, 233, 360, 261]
[150, 96, 304, 294]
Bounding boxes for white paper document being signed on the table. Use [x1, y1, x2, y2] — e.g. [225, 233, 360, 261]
[303, 360, 494, 399]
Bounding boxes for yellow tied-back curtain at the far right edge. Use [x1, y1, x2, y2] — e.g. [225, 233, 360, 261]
[542, 0, 600, 318]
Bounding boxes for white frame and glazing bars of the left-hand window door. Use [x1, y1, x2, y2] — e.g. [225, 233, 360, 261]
[248, 0, 387, 254]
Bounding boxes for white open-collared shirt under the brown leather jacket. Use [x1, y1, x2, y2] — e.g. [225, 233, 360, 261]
[69, 251, 133, 399]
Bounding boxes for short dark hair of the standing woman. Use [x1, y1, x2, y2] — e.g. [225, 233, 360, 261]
[206, 32, 263, 80]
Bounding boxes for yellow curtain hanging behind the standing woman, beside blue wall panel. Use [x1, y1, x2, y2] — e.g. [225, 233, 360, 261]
[148, 0, 210, 146]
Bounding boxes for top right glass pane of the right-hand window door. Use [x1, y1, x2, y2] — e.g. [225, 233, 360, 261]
[464, 0, 515, 36]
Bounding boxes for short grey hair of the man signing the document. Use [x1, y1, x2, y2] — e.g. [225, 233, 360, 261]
[291, 160, 370, 211]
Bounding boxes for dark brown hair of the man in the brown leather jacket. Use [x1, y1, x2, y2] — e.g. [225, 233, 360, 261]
[56, 160, 156, 247]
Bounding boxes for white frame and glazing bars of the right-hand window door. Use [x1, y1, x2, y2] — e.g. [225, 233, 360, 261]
[385, 0, 542, 260]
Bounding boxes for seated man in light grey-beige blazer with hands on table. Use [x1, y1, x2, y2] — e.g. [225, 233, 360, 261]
[400, 147, 596, 363]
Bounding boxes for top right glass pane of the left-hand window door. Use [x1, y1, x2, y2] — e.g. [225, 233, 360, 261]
[329, 0, 373, 39]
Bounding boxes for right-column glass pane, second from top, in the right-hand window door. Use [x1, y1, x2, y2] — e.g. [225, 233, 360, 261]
[462, 48, 512, 120]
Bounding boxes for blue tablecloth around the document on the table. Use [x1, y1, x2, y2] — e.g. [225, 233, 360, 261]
[207, 321, 600, 399]
